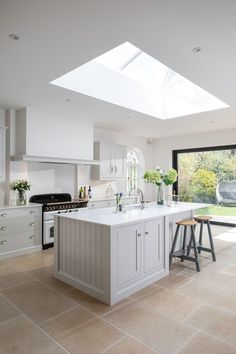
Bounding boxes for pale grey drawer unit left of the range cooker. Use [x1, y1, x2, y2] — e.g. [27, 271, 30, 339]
[0, 206, 42, 259]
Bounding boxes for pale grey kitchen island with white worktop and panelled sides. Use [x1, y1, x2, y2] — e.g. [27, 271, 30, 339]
[54, 203, 206, 305]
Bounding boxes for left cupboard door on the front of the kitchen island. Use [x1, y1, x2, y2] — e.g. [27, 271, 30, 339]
[117, 224, 141, 286]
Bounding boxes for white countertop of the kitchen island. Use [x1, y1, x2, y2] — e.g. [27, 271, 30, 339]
[56, 203, 209, 226]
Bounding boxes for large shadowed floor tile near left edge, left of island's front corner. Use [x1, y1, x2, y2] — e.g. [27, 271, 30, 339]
[3, 281, 76, 323]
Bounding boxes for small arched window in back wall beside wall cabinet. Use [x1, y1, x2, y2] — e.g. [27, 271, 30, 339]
[127, 148, 144, 191]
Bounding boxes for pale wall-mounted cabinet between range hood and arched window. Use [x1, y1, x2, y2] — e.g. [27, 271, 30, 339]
[92, 142, 127, 180]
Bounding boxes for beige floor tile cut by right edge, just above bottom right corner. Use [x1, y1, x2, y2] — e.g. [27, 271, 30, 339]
[187, 305, 236, 344]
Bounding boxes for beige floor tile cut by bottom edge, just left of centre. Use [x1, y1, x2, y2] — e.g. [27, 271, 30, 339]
[59, 319, 124, 354]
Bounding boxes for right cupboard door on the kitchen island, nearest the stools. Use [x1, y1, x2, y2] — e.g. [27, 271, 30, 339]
[144, 220, 165, 273]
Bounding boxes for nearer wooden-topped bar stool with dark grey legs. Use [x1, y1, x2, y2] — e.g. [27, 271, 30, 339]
[169, 220, 200, 272]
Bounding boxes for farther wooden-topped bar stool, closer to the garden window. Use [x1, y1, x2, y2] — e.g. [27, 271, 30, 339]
[193, 215, 216, 262]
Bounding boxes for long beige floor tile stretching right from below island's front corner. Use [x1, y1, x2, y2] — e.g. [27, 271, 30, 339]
[104, 302, 196, 354]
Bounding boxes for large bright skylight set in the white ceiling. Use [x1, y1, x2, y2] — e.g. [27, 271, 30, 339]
[51, 42, 228, 119]
